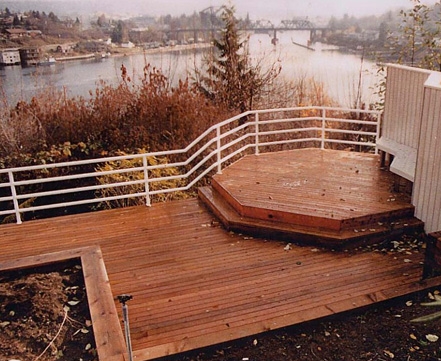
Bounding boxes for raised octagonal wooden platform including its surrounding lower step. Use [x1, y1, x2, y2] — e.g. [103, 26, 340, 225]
[199, 149, 422, 247]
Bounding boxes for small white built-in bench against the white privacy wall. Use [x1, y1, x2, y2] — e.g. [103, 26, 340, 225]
[377, 137, 417, 182]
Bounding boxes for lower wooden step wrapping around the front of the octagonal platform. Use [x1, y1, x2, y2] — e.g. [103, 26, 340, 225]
[198, 186, 424, 249]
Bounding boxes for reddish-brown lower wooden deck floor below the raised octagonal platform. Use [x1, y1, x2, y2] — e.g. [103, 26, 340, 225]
[0, 150, 441, 361]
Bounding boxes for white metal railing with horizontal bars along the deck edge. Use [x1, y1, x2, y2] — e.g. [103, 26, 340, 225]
[0, 106, 381, 223]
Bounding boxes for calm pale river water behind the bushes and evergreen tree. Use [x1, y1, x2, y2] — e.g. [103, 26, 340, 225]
[0, 31, 378, 106]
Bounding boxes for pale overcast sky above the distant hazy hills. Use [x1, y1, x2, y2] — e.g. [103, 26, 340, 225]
[8, 0, 440, 20]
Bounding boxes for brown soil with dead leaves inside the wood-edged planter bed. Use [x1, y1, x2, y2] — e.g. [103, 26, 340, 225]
[0, 260, 97, 361]
